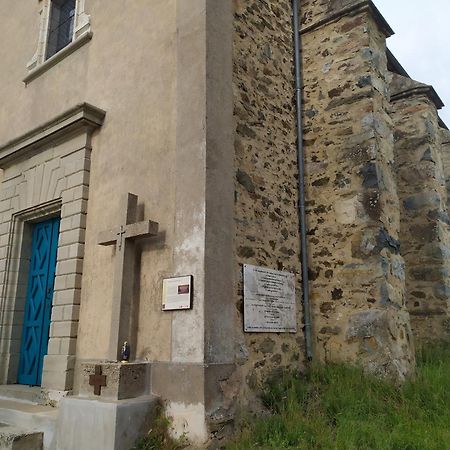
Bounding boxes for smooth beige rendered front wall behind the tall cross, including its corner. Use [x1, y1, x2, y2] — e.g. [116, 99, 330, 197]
[0, 0, 235, 442]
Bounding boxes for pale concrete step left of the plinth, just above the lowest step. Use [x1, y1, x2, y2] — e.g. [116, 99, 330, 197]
[0, 399, 58, 450]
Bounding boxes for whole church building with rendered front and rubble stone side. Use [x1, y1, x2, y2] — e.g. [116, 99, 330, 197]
[0, 0, 450, 450]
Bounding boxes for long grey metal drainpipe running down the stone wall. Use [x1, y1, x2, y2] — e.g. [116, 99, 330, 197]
[292, 0, 313, 361]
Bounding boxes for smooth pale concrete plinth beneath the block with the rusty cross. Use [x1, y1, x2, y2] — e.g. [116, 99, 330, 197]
[56, 396, 158, 450]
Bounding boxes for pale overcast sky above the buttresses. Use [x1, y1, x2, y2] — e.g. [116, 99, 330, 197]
[374, 0, 450, 128]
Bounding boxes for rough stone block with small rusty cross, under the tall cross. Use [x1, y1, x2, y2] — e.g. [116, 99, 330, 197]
[79, 362, 150, 400]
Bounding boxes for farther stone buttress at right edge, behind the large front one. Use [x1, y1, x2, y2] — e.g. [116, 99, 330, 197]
[391, 74, 450, 345]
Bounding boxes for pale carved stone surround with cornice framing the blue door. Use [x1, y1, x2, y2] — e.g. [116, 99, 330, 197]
[0, 103, 105, 391]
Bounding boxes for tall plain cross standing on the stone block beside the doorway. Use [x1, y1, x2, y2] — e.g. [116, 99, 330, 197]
[98, 194, 158, 361]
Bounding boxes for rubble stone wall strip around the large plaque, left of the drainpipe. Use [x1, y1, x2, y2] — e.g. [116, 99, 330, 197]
[233, 0, 305, 402]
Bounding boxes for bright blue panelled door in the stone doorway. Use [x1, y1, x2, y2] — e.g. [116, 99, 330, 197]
[17, 218, 60, 386]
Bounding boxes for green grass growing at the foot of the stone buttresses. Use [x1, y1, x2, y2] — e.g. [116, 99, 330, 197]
[226, 344, 450, 450]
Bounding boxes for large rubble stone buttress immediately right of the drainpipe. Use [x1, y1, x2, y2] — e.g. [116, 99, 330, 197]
[301, 0, 414, 379]
